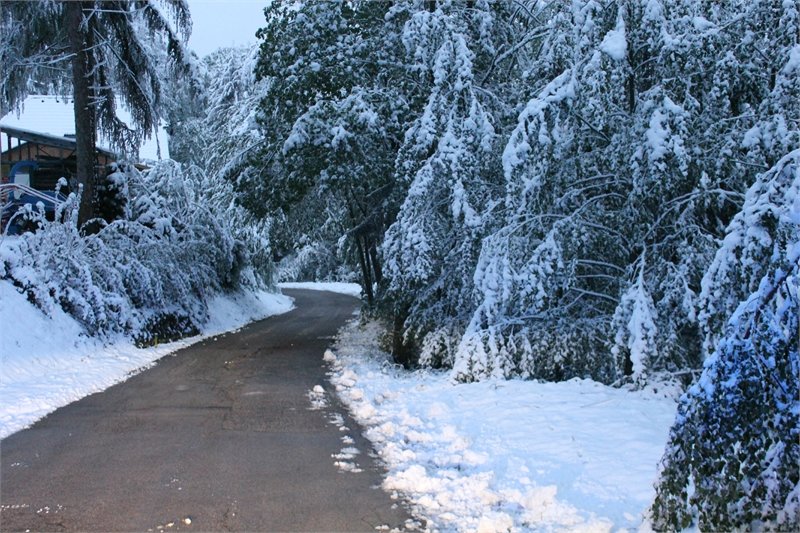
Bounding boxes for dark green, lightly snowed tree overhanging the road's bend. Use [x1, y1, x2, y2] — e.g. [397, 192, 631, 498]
[253, 1, 416, 300]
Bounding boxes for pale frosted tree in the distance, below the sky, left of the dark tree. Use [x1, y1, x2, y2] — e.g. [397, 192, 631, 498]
[158, 47, 274, 286]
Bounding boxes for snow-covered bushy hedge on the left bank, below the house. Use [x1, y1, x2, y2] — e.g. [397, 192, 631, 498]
[0, 161, 271, 344]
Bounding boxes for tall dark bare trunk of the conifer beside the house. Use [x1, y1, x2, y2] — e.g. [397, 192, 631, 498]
[64, 2, 95, 225]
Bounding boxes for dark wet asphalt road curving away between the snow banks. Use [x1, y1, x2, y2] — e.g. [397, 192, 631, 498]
[0, 290, 409, 532]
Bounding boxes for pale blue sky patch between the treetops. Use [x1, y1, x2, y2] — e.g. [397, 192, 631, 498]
[187, 0, 269, 57]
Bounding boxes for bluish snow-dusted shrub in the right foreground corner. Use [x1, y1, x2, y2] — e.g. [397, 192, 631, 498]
[652, 151, 800, 531]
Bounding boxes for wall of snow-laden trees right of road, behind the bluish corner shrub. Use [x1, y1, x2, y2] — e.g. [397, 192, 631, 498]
[252, 0, 800, 384]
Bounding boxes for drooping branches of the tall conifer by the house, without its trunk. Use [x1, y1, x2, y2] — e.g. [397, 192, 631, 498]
[0, 0, 192, 153]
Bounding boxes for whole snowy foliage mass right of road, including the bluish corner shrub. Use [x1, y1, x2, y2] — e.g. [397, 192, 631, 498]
[247, 5, 800, 520]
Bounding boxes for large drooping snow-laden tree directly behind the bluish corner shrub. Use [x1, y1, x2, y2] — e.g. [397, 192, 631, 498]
[456, 0, 800, 382]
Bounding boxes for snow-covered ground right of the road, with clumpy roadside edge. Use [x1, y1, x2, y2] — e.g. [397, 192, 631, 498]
[322, 323, 676, 532]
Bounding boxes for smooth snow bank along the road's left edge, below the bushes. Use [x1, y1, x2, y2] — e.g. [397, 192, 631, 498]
[0, 280, 292, 438]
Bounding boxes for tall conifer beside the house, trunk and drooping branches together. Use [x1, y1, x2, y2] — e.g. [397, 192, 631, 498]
[0, 0, 191, 222]
